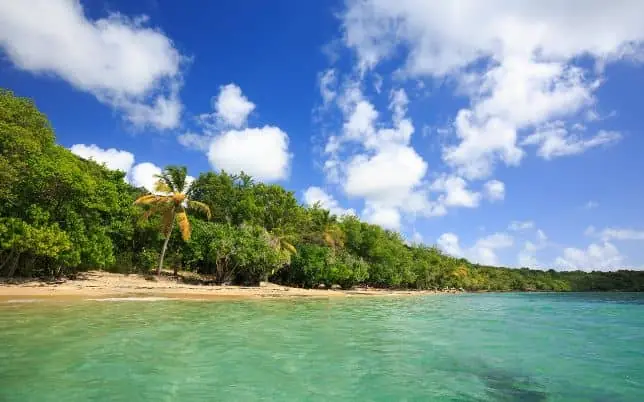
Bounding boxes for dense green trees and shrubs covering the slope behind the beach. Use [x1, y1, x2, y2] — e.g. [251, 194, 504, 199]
[0, 91, 644, 291]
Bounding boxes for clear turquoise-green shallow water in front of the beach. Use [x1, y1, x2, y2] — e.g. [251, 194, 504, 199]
[0, 294, 644, 402]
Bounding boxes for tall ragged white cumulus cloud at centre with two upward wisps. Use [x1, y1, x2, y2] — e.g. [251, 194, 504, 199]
[324, 82, 438, 229]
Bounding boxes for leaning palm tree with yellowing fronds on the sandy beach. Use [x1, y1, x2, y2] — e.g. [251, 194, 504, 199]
[134, 166, 210, 275]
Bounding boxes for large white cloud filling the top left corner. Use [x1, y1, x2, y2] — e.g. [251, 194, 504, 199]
[0, 0, 182, 129]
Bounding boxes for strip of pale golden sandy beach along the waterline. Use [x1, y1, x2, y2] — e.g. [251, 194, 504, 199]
[0, 271, 434, 300]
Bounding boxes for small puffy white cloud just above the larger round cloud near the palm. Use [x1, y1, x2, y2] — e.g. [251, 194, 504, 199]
[208, 83, 255, 128]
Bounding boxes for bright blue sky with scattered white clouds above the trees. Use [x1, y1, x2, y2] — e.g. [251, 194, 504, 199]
[0, 0, 644, 270]
